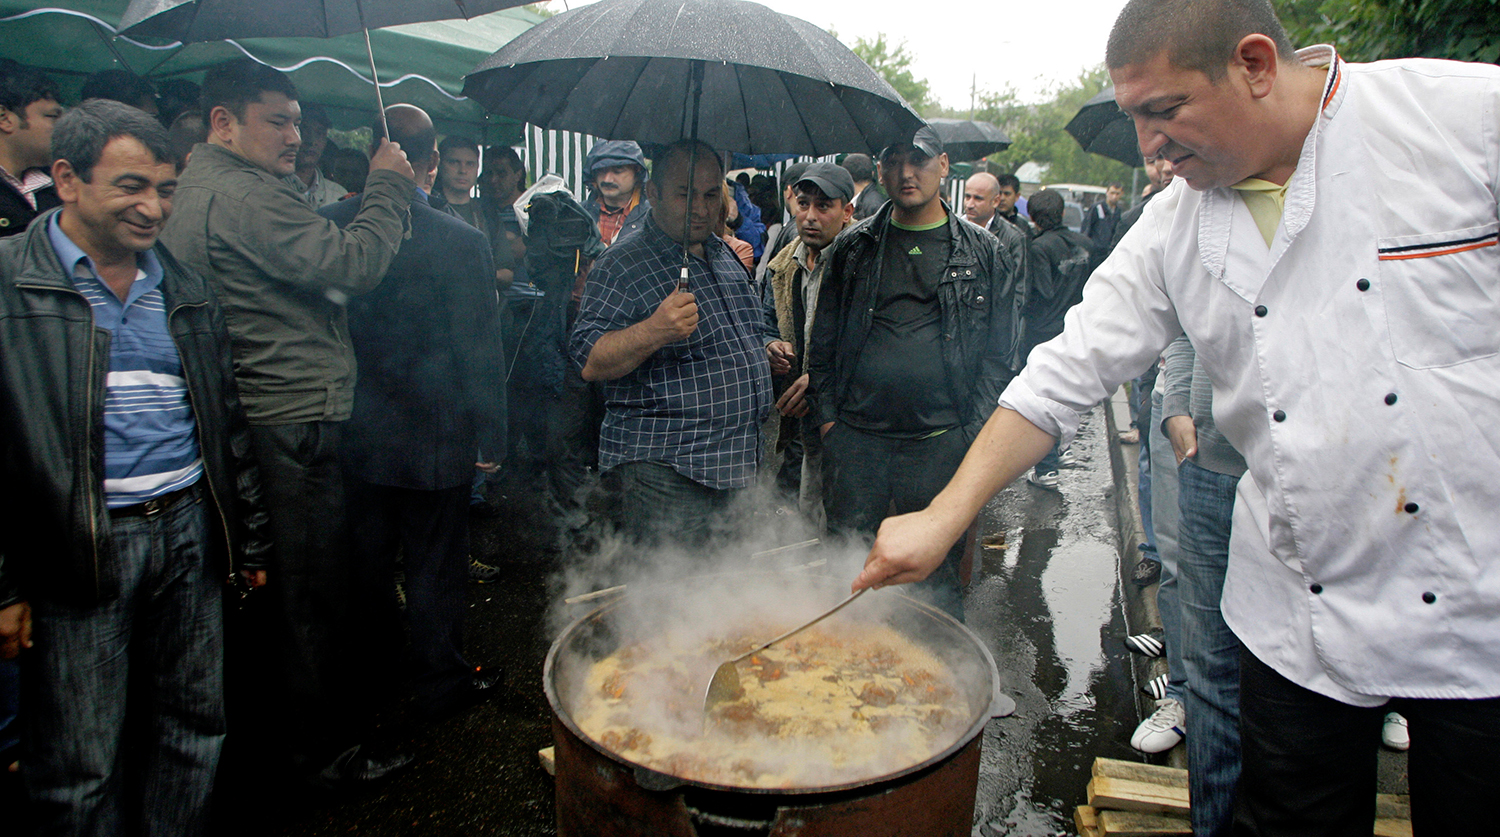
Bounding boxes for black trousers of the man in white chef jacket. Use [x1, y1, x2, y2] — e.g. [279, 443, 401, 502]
[1235, 651, 1500, 837]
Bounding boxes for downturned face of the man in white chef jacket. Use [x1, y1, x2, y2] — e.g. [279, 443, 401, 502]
[1110, 51, 1259, 192]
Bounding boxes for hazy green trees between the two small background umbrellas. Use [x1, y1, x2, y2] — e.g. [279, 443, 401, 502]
[945, 65, 1131, 185]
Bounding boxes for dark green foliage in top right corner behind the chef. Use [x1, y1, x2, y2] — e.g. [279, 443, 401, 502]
[1275, 0, 1500, 65]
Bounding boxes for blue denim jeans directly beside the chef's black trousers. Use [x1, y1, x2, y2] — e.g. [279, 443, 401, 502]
[1178, 459, 1241, 837]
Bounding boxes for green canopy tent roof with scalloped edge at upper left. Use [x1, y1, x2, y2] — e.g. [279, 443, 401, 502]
[0, 0, 543, 144]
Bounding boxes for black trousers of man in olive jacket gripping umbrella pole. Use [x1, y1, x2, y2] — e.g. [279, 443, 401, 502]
[230, 422, 360, 767]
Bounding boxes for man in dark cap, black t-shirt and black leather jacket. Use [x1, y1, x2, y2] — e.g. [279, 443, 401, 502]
[809, 128, 1026, 618]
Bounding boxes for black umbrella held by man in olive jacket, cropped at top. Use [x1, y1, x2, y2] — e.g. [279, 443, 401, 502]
[120, 0, 527, 135]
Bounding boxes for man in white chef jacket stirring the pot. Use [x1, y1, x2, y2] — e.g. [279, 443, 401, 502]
[855, 0, 1500, 836]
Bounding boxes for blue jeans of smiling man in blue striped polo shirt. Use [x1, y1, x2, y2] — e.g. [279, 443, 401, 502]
[21, 495, 225, 836]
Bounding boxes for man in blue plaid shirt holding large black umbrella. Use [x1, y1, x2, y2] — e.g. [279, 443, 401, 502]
[573, 141, 773, 555]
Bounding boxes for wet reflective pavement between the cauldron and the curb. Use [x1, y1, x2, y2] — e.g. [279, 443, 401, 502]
[966, 411, 1139, 837]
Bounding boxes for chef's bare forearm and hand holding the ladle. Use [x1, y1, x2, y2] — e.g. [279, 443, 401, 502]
[854, 407, 1058, 590]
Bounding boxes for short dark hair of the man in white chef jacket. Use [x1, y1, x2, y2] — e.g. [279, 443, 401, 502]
[1104, 0, 1296, 83]
